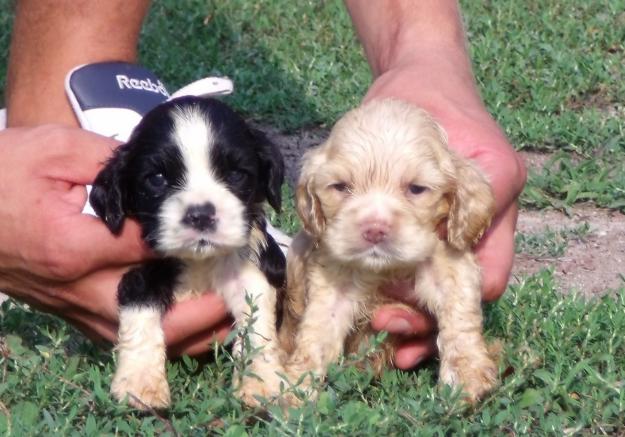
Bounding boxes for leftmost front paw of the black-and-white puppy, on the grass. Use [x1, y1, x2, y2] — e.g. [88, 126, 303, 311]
[111, 370, 170, 410]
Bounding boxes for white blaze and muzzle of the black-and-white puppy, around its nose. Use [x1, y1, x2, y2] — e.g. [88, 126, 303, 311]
[157, 104, 247, 258]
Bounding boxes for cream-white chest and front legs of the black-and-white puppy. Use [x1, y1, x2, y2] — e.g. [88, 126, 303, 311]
[111, 229, 281, 409]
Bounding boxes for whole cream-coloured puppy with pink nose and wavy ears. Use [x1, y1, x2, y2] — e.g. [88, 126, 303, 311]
[280, 100, 497, 402]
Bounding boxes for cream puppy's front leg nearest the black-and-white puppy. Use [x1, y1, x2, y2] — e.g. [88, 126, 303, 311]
[285, 273, 361, 405]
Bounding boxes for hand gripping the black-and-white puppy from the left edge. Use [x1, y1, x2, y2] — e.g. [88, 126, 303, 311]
[0, 126, 146, 326]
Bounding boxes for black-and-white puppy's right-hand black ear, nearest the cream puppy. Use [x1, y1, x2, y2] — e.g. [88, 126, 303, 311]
[250, 129, 284, 212]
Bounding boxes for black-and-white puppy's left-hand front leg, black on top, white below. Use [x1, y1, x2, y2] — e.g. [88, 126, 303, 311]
[111, 260, 178, 409]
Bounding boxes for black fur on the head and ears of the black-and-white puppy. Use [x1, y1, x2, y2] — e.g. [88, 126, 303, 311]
[89, 97, 284, 248]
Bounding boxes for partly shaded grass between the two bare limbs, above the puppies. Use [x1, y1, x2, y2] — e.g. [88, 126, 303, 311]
[136, 0, 369, 129]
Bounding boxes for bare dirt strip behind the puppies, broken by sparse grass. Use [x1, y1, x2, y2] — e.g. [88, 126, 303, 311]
[270, 132, 625, 295]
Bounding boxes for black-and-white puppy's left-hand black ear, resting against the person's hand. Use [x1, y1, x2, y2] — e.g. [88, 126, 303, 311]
[89, 144, 129, 235]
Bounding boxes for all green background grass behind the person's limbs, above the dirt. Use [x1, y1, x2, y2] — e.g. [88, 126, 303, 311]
[0, 0, 625, 210]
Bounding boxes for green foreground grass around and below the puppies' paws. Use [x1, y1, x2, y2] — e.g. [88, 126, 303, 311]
[0, 270, 625, 436]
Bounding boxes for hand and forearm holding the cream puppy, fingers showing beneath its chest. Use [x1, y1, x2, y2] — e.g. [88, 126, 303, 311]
[346, 0, 526, 369]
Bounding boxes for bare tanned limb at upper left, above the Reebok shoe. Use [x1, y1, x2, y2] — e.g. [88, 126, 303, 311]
[7, 0, 150, 126]
